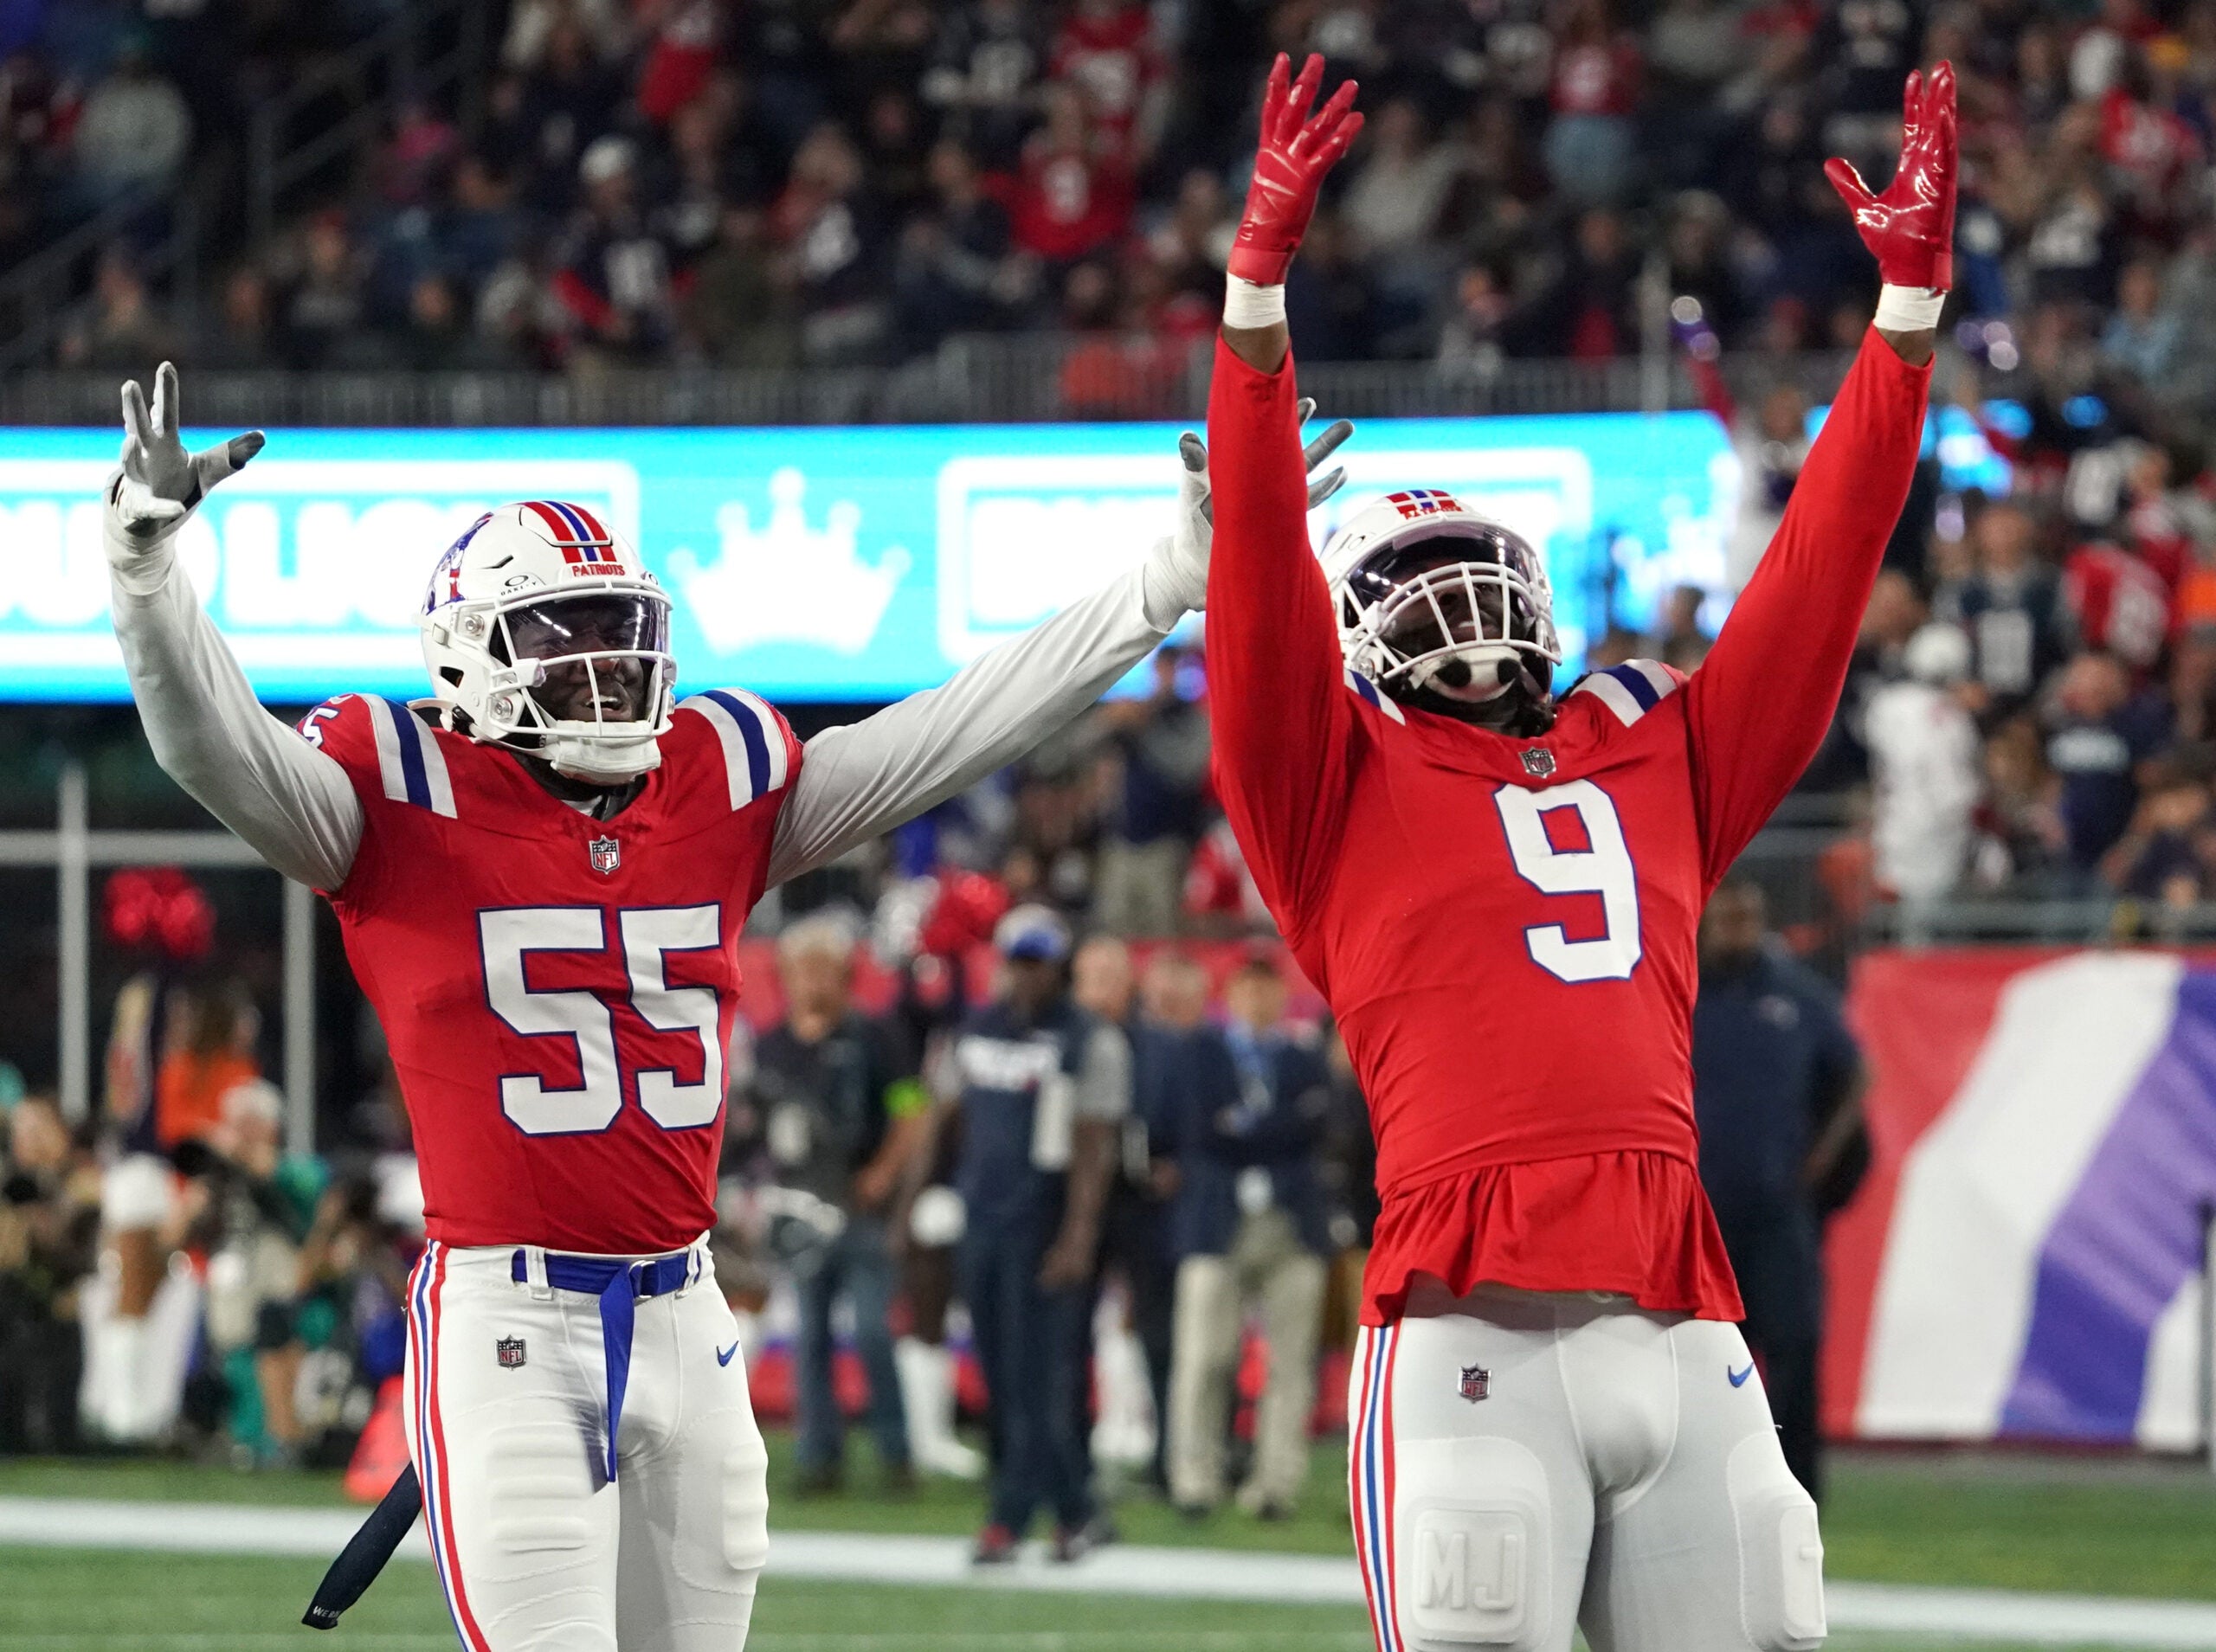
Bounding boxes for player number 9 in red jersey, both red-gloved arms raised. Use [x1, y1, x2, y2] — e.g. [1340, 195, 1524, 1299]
[1208, 58, 1955, 1652]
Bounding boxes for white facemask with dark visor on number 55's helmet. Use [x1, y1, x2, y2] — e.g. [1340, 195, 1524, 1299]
[459, 589, 676, 786]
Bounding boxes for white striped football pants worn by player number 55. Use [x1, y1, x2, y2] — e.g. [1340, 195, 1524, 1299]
[403, 1243, 769, 1652]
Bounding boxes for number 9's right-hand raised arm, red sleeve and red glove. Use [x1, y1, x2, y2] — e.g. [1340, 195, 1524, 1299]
[1686, 62, 1955, 884]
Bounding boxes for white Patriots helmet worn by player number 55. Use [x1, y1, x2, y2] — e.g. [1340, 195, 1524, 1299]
[421, 498, 676, 786]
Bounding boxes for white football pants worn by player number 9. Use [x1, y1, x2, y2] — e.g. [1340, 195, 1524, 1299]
[1347, 1284, 1824, 1652]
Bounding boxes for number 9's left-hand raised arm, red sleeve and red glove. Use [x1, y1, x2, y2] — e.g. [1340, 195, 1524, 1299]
[1208, 55, 1361, 935]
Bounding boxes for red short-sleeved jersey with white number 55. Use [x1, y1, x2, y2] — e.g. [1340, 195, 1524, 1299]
[301, 691, 800, 1256]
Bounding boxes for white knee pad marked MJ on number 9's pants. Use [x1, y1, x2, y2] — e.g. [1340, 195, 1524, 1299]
[1392, 1437, 1556, 1652]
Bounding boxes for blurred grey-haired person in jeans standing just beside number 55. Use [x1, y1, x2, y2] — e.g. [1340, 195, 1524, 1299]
[749, 915, 926, 1493]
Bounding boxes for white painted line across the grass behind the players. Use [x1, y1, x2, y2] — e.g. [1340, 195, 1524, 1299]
[0, 1497, 2216, 1652]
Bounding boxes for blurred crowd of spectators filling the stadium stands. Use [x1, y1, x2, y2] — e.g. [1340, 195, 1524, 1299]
[13, 0, 2216, 912]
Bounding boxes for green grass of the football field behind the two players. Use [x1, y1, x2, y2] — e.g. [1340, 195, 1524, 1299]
[0, 1442, 2216, 1652]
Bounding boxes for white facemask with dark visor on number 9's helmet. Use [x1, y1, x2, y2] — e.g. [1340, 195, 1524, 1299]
[1338, 520, 1562, 726]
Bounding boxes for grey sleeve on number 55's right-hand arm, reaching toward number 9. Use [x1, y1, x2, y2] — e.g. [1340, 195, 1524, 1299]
[769, 569, 1168, 886]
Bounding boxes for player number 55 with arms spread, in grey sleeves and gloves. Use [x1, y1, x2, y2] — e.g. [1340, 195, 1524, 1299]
[106, 365, 1347, 1652]
